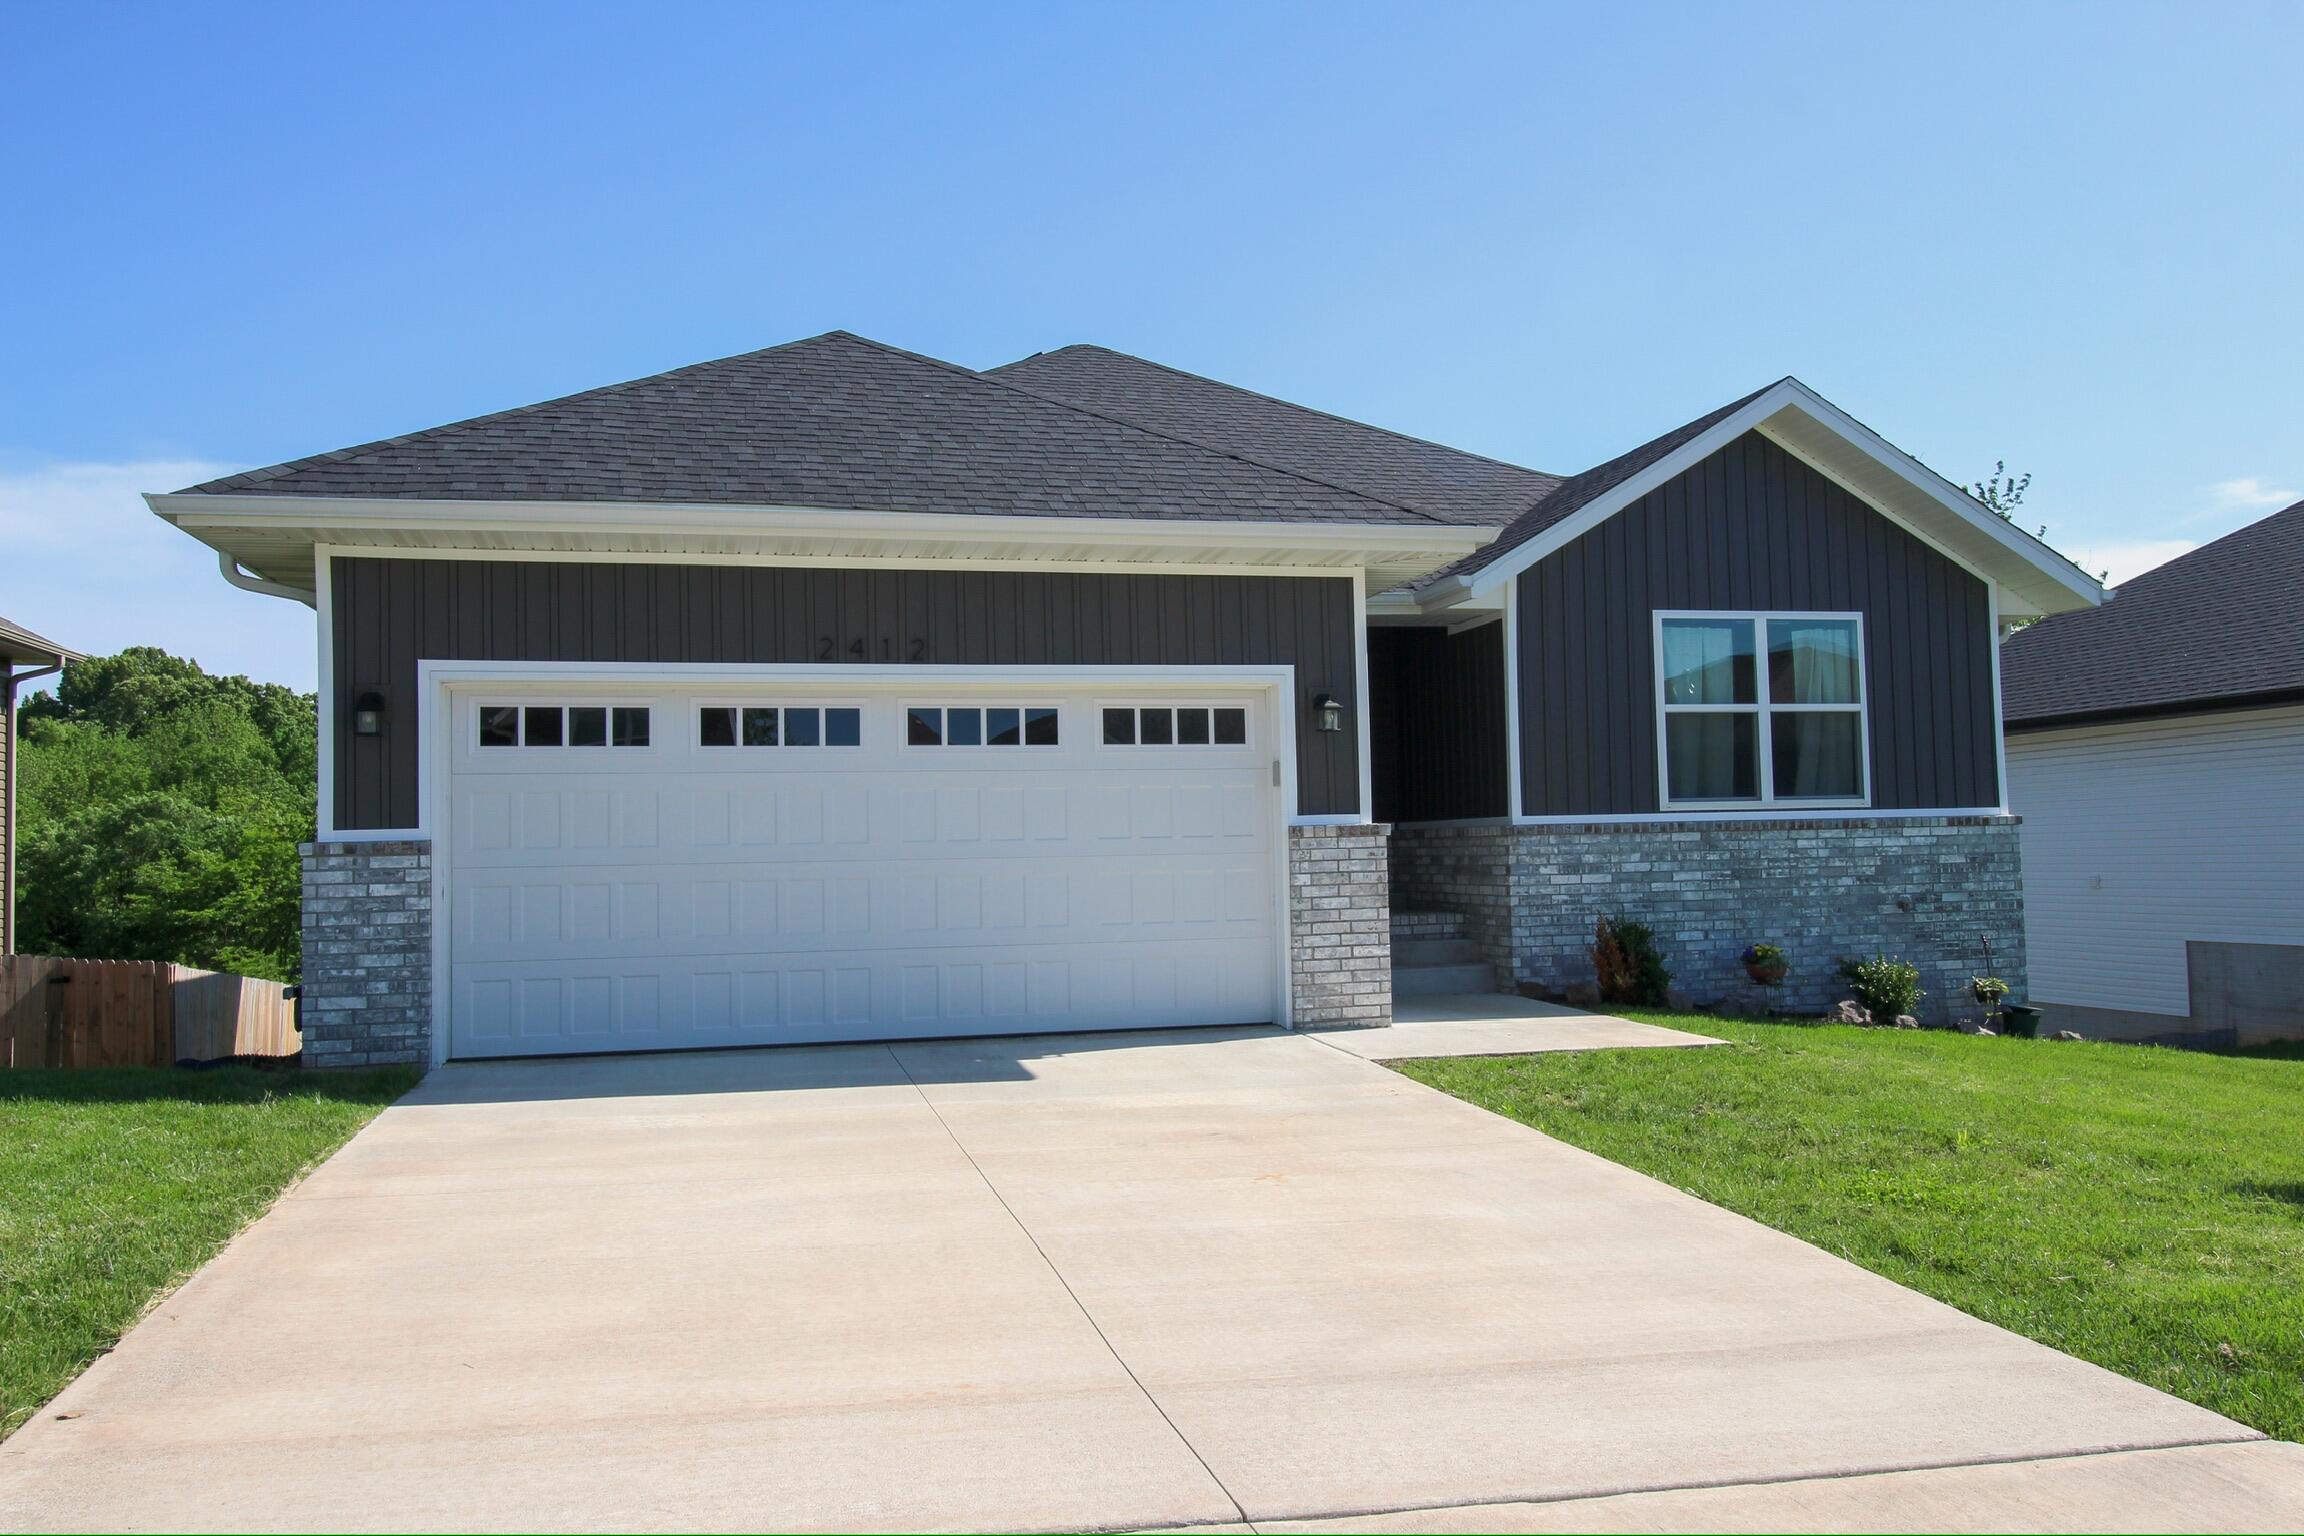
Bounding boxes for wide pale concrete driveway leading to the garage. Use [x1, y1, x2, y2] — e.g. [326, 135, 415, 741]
[0, 1029, 2304, 1529]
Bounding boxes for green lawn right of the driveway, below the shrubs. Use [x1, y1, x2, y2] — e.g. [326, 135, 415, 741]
[1399, 1013, 2304, 1439]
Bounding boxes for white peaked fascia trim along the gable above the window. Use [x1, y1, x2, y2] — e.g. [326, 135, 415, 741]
[1422, 378, 2104, 613]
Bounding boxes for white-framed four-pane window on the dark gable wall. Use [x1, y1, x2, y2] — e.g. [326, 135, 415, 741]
[1654, 610, 1871, 811]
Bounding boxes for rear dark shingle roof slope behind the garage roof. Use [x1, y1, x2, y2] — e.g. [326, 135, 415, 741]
[986, 345, 1560, 527]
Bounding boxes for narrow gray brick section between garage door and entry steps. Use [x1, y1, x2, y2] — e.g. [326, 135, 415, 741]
[1288, 822, 1392, 1029]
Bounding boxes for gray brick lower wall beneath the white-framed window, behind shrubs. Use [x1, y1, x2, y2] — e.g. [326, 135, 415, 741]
[1392, 815, 2025, 1022]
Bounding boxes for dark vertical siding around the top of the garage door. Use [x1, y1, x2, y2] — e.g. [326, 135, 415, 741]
[329, 555, 1359, 831]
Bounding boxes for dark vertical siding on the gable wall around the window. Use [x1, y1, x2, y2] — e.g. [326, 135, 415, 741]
[1518, 433, 2000, 815]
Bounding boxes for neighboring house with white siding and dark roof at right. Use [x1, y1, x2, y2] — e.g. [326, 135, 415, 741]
[2002, 502, 2304, 1045]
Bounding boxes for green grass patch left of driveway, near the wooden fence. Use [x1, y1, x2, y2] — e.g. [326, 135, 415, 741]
[0, 1066, 417, 1435]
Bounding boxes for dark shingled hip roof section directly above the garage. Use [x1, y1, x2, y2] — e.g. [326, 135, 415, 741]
[189, 332, 1445, 525]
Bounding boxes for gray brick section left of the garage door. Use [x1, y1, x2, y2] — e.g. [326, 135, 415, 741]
[300, 841, 433, 1066]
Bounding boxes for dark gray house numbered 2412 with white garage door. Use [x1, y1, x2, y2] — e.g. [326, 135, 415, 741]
[150, 332, 2101, 1062]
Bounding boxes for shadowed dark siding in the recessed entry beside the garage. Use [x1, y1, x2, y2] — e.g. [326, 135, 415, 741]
[1369, 622, 1509, 822]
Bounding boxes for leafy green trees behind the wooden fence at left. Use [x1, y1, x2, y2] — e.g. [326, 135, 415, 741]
[16, 647, 318, 981]
